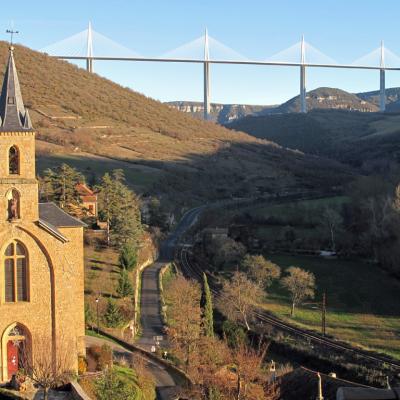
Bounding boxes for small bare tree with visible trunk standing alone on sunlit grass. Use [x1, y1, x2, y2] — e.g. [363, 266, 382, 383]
[282, 267, 315, 317]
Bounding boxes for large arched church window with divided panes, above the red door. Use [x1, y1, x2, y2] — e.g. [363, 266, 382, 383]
[4, 240, 28, 303]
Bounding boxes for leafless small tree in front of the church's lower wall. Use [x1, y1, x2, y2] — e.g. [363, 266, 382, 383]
[21, 335, 75, 400]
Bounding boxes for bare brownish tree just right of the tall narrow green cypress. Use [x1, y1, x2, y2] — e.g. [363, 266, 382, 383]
[218, 272, 264, 330]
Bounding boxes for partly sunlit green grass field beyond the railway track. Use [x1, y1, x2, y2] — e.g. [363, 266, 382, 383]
[263, 255, 400, 359]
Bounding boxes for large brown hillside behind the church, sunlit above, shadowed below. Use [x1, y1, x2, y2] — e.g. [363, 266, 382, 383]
[0, 42, 349, 209]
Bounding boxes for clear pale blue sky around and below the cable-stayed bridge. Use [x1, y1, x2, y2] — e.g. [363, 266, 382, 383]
[0, 0, 400, 105]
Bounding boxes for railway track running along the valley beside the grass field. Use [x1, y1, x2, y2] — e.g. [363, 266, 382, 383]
[176, 246, 400, 370]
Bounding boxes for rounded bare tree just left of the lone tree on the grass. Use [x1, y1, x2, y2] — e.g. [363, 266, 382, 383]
[241, 254, 281, 287]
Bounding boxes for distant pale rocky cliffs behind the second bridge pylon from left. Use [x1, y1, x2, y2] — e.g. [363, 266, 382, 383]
[165, 101, 275, 125]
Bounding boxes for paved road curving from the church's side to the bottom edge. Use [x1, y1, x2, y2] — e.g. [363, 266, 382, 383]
[85, 336, 176, 400]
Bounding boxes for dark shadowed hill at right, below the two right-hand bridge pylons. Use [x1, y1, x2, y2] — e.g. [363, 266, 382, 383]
[229, 110, 400, 172]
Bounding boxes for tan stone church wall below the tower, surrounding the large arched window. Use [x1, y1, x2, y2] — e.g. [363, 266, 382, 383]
[0, 221, 85, 381]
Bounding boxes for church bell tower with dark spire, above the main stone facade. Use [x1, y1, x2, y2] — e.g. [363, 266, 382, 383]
[0, 46, 38, 224]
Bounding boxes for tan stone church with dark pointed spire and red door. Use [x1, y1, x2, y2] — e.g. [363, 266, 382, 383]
[0, 46, 85, 382]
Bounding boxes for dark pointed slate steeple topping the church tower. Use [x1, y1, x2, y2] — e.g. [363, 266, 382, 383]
[0, 46, 32, 132]
